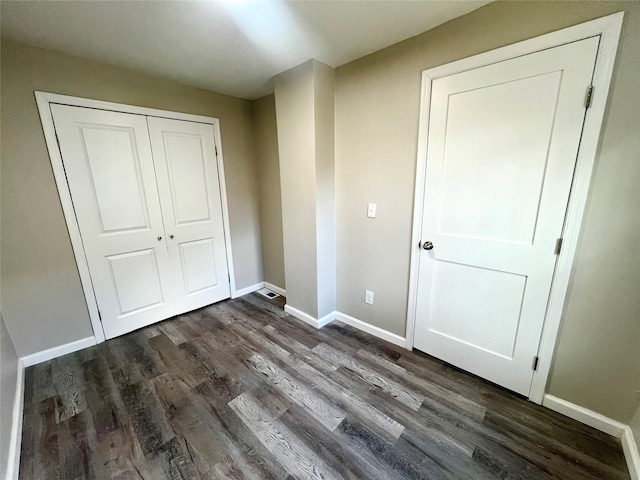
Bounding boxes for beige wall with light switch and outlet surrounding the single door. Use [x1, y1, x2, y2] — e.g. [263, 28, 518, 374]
[335, 1, 640, 422]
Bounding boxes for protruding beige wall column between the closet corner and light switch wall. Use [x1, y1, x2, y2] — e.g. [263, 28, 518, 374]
[275, 60, 336, 319]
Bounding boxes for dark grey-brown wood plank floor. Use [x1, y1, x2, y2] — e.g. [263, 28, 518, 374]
[20, 294, 629, 480]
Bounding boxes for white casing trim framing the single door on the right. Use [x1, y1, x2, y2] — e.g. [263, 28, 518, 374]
[405, 12, 624, 404]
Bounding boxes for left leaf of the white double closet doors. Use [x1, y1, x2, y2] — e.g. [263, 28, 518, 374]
[51, 105, 176, 338]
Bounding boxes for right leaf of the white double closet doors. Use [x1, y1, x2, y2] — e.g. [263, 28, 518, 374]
[148, 117, 230, 312]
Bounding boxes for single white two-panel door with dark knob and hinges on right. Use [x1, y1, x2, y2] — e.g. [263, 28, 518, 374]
[414, 37, 598, 395]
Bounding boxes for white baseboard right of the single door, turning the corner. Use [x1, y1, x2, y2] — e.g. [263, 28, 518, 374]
[542, 395, 640, 480]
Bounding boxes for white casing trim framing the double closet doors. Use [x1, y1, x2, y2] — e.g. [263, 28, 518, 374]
[35, 91, 236, 343]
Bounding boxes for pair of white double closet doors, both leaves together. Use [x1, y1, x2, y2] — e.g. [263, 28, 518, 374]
[51, 105, 230, 338]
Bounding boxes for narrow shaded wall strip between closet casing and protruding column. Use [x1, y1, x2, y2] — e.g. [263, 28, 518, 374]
[253, 94, 286, 289]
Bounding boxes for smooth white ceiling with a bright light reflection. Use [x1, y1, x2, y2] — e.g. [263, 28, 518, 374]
[0, 0, 489, 99]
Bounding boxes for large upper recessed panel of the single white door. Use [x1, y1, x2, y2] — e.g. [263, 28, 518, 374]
[438, 72, 561, 244]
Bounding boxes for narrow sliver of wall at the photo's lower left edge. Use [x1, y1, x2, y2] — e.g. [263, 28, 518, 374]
[0, 313, 18, 478]
